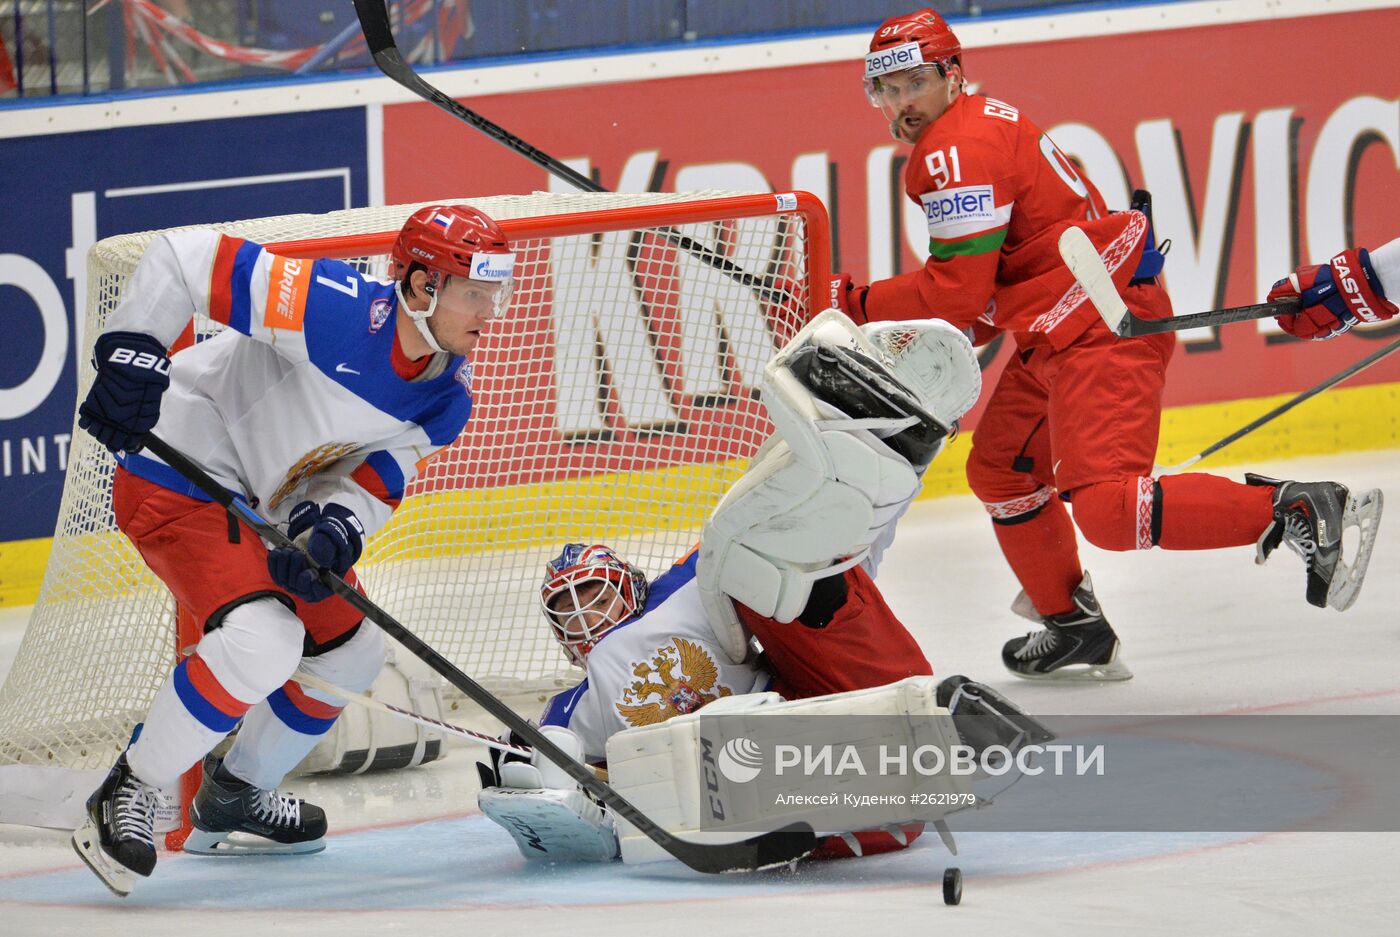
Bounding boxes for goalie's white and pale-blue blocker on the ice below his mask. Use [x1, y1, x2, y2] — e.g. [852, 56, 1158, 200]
[476, 726, 617, 863]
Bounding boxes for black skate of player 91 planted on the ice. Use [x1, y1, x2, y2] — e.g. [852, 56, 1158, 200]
[1001, 573, 1133, 682]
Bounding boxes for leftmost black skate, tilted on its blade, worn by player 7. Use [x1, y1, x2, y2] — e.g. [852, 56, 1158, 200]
[73, 754, 162, 898]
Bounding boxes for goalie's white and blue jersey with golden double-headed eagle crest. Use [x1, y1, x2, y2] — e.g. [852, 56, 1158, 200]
[540, 550, 771, 762]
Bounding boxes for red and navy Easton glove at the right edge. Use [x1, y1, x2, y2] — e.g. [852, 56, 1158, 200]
[1268, 249, 1396, 342]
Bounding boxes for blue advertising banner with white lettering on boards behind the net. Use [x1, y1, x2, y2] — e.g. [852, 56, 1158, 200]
[0, 108, 368, 542]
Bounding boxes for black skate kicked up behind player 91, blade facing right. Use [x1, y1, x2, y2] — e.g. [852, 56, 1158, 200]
[1245, 473, 1385, 612]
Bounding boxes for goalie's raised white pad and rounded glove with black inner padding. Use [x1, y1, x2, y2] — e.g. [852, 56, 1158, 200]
[697, 310, 981, 662]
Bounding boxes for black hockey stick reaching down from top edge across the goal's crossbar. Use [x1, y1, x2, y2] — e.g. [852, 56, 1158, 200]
[345, 0, 795, 304]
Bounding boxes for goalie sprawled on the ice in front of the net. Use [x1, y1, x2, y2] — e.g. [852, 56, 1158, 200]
[479, 310, 1050, 861]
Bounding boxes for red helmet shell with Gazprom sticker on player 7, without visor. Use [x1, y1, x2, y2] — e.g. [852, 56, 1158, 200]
[389, 204, 515, 283]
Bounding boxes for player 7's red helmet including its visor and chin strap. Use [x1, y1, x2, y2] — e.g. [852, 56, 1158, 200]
[389, 204, 515, 352]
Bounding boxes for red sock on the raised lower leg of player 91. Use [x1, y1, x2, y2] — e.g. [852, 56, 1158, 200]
[1158, 472, 1274, 550]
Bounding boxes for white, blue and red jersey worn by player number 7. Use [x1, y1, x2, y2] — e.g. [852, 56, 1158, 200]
[105, 231, 472, 534]
